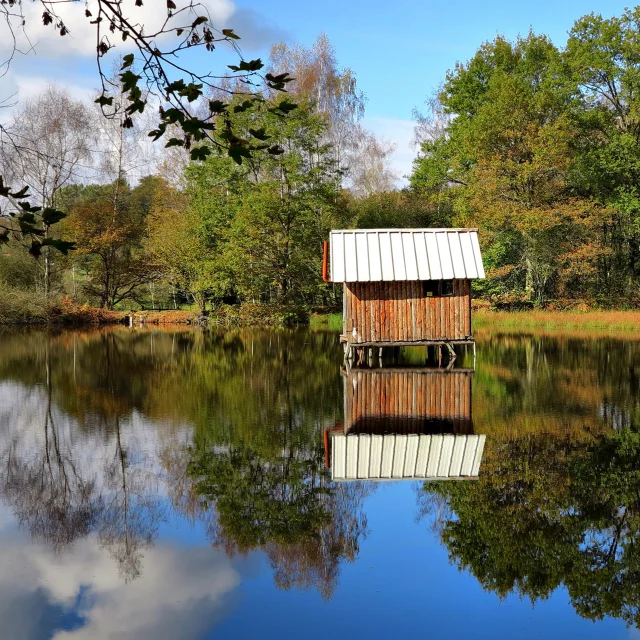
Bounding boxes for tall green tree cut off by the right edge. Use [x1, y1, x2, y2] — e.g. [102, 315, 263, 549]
[563, 7, 640, 297]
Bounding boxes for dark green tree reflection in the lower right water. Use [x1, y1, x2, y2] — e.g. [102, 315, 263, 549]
[421, 426, 640, 626]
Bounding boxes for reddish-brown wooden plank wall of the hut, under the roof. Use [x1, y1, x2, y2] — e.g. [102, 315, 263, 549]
[343, 280, 472, 343]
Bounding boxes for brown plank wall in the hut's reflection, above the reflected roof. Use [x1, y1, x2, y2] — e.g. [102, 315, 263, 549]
[344, 369, 473, 433]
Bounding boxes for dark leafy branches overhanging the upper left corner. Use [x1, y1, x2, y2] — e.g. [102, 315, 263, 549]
[0, 0, 296, 255]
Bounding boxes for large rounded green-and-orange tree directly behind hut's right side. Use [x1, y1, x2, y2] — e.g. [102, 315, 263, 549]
[412, 34, 609, 302]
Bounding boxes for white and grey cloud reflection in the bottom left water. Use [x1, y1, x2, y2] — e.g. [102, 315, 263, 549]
[0, 536, 240, 640]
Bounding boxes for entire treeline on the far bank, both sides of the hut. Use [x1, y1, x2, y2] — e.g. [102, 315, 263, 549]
[0, 8, 640, 320]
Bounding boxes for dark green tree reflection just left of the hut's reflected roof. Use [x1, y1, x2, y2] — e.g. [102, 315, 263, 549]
[175, 445, 369, 598]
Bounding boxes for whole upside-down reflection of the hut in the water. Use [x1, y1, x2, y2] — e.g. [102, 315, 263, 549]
[325, 368, 485, 480]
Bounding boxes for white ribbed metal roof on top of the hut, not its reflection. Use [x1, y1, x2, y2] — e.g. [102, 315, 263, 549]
[330, 229, 485, 282]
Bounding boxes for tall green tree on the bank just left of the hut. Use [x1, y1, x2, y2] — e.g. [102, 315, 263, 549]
[189, 96, 339, 303]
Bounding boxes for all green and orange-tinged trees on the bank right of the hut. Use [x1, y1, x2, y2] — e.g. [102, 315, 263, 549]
[411, 9, 640, 302]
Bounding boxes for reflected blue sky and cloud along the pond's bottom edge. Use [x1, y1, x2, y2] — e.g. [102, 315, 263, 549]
[0, 483, 635, 640]
